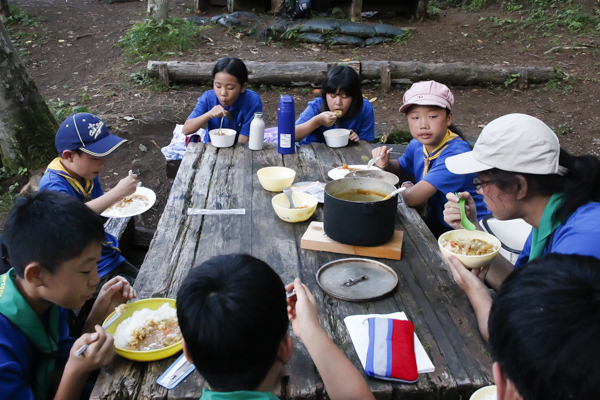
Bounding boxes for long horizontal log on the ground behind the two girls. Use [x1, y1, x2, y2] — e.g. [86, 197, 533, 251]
[147, 61, 554, 86]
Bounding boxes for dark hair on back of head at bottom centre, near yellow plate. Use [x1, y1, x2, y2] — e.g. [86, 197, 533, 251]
[177, 254, 288, 392]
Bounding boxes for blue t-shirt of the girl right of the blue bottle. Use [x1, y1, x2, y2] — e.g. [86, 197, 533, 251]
[296, 97, 375, 144]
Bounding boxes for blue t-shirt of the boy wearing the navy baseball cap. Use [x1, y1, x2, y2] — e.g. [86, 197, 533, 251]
[40, 171, 125, 278]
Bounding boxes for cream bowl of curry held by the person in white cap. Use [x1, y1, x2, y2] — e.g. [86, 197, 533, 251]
[438, 229, 501, 268]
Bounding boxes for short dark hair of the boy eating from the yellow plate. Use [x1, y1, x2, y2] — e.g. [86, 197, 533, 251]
[4, 190, 106, 278]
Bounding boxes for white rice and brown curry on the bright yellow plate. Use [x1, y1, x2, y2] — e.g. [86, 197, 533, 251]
[114, 303, 182, 351]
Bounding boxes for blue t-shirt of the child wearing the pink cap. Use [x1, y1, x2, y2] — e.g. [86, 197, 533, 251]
[398, 138, 490, 233]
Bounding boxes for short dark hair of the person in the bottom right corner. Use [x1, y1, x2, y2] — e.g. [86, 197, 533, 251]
[488, 254, 600, 400]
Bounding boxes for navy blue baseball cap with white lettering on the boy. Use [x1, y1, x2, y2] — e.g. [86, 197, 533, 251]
[54, 113, 127, 157]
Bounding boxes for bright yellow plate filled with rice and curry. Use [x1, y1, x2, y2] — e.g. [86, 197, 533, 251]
[106, 299, 182, 361]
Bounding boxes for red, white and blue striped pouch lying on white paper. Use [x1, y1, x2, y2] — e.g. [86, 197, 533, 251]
[365, 317, 419, 383]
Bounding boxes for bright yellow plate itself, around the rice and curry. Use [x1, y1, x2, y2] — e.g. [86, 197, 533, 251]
[104, 299, 182, 361]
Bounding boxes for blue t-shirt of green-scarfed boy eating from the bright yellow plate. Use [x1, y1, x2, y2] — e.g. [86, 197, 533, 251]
[0, 307, 74, 400]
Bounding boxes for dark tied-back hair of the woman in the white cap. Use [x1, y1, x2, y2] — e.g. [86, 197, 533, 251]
[484, 149, 600, 223]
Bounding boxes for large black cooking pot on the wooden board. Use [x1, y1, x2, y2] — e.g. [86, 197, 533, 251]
[323, 178, 398, 246]
